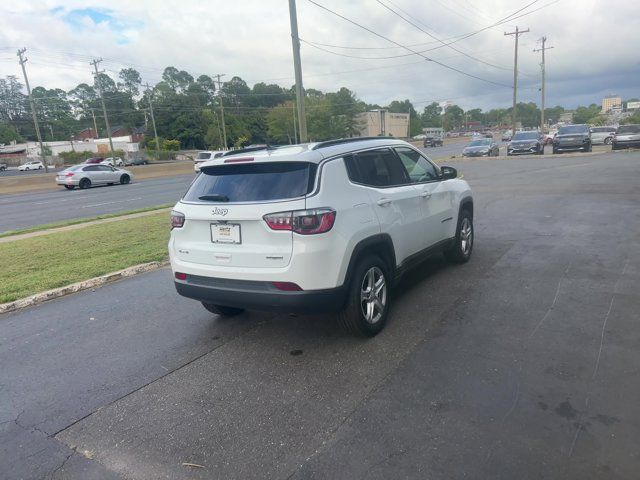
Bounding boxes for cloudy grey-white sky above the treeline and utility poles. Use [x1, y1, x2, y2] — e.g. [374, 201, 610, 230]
[0, 0, 640, 110]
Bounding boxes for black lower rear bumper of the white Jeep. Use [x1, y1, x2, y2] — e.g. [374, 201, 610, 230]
[174, 275, 347, 313]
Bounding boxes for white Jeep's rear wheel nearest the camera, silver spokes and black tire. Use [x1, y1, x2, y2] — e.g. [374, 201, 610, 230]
[338, 255, 391, 337]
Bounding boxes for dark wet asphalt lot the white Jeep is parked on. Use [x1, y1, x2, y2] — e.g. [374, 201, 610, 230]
[0, 152, 640, 480]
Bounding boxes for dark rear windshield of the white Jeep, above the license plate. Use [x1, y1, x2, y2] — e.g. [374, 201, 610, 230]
[183, 162, 317, 203]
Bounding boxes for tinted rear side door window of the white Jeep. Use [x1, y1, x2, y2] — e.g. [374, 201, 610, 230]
[345, 148, 408, 187]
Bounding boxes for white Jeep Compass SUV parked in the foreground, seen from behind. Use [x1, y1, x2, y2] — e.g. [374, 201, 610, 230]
[169, 138, 473, 336]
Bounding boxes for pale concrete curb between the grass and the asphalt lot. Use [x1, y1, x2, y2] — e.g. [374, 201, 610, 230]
[0, 260, 169, 314]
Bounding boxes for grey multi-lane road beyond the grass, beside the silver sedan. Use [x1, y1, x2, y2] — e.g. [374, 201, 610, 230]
[0, 174, 193, 233]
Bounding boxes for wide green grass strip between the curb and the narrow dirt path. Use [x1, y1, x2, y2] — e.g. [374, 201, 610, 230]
[0, 212, 169, 303]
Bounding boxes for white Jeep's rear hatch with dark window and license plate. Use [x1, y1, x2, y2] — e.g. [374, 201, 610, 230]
[174, 161, 316, 268]
